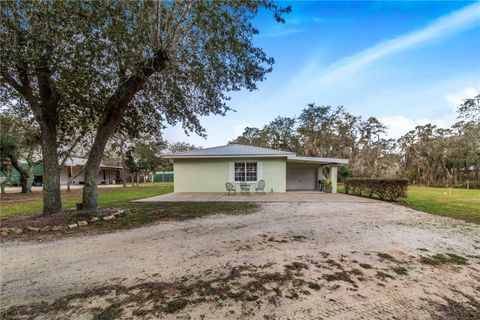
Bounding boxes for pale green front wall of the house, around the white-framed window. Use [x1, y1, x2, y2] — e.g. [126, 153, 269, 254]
[173, 158, 286, 192]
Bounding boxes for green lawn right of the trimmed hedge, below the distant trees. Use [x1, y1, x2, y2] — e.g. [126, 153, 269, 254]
[338, 184, 480, 224]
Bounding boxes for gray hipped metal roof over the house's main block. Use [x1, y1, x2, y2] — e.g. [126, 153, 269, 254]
[164, 144, 295, 159]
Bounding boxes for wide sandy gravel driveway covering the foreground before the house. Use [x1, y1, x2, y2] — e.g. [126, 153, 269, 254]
[1, 201, 480, 319]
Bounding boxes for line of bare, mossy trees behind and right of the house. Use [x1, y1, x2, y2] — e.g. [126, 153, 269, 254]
[230, 95, 480, 187]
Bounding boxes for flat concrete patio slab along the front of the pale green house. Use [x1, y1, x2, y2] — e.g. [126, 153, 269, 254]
[134, 191, 376, 203]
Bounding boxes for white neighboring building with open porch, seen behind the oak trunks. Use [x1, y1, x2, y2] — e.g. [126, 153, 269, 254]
[60, 157, 122, 185]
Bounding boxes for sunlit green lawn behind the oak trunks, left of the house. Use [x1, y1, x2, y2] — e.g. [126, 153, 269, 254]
[0, 182, 173, 218]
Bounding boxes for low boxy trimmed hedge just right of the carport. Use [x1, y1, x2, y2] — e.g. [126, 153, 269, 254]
[345, 178, 408, 201]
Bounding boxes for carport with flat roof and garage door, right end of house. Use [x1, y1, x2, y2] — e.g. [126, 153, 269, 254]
[286, 156, 348, 193]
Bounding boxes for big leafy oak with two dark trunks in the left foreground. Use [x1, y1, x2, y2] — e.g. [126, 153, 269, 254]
[0, 0, 290, 212]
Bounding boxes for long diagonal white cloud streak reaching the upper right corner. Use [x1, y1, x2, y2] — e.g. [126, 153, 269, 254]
[317, 3, 480, 84]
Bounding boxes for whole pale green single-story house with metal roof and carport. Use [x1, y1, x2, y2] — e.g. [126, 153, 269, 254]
[164, 144, 348, 192]
